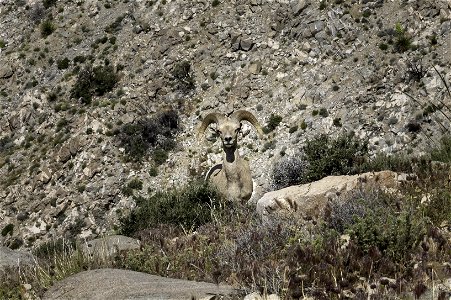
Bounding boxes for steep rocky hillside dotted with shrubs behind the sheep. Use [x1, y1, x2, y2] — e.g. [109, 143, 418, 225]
[0, 0, 451, 248]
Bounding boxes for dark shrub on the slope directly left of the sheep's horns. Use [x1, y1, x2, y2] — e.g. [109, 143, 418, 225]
[117, 110, 179, 164]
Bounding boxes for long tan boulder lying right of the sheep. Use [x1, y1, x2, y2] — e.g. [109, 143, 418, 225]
[257, 171, 410, 219]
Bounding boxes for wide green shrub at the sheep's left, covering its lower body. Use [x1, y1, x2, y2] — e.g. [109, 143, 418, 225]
[121, 182, 221, 235]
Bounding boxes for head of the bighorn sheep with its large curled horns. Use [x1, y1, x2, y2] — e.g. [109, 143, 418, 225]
[198, 110, 263, 148]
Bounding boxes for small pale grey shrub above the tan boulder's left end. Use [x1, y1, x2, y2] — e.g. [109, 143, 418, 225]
[271, 157, 307, 190]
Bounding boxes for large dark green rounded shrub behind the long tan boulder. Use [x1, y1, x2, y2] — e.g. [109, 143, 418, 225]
[301, 134, 368, 182]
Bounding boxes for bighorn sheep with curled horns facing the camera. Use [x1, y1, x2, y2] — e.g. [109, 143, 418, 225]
[198, 110, 263, 201]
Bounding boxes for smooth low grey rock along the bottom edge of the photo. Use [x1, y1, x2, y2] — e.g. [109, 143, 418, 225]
[42, 269, 234, 300]
